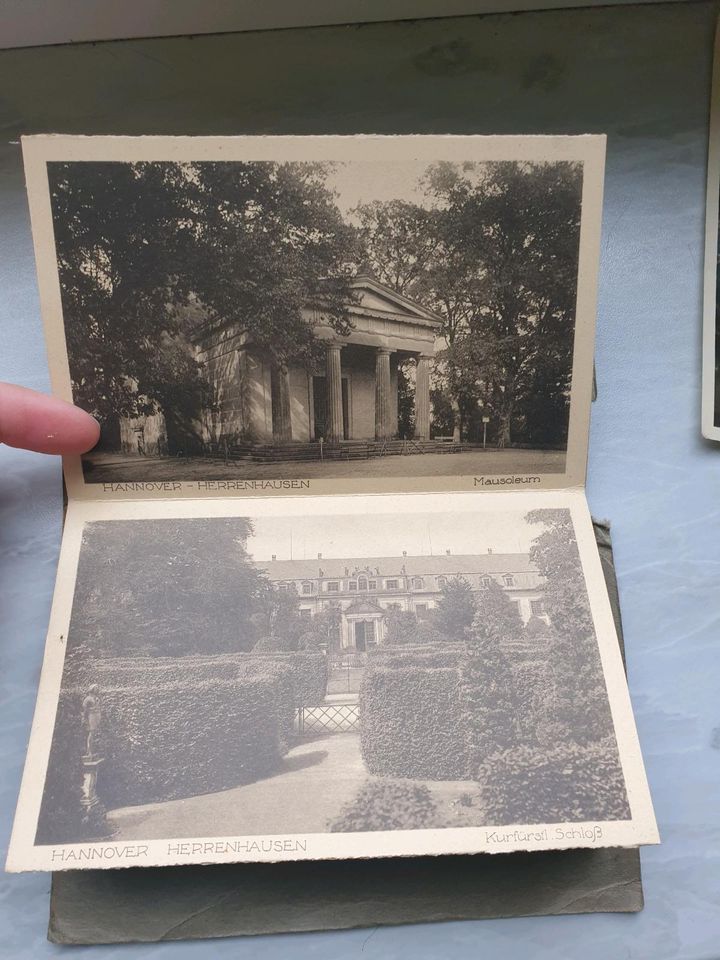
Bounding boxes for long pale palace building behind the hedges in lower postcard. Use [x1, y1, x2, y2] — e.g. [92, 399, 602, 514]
[255, 551, 547, 652]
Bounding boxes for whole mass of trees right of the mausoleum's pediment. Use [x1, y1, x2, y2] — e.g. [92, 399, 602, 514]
[359, 162, 582, 445]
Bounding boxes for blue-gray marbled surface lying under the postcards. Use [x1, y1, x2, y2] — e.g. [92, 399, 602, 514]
[0, 3, 720, 960]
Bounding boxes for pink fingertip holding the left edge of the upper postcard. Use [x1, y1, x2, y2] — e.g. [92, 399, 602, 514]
[0, 383, 100, 453]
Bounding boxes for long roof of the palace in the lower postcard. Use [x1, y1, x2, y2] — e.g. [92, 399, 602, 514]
[255, 553, 537, 580]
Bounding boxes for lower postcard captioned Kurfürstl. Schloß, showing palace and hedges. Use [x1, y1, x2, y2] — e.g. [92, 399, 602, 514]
[7, 490, 658, 871]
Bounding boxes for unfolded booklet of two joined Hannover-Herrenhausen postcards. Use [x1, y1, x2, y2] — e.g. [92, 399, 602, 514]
[7, 136, 658, 871]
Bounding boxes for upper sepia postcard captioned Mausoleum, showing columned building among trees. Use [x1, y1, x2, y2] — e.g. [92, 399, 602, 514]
[23, 136, 605, 500]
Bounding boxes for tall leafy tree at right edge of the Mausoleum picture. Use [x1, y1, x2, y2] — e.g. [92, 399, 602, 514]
[429, 162, 582, 444]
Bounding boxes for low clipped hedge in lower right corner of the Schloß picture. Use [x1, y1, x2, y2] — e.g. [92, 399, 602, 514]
[477, 738, 630, 826]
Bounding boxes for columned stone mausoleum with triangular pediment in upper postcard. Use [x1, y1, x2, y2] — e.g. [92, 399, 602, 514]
[195, 276, 441, 443]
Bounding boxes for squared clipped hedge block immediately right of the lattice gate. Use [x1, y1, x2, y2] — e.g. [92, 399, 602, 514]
[360, 662, 466, 780]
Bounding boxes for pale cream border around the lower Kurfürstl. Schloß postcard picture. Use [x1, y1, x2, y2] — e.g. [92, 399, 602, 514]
[6, 490, 659, 872]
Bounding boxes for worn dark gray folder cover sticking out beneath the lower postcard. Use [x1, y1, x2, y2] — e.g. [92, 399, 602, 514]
[48, 522, 643, 944]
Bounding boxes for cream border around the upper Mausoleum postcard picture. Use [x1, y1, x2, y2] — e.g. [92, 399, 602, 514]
[22, 134, 605, 500]
